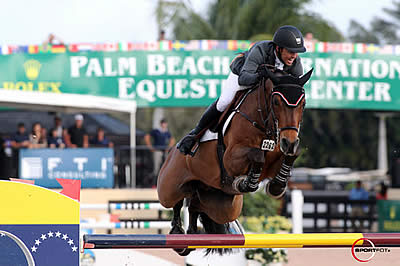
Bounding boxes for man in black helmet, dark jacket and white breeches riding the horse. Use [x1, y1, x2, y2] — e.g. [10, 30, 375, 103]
[177, 26, 306, 154]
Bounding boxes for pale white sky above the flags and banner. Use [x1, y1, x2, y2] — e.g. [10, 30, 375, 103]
[0, 0, 392, 45]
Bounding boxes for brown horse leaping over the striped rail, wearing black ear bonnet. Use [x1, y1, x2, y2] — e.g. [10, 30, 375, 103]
[157, 66, 312, 256]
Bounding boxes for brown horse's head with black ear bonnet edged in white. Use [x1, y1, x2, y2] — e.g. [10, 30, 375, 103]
[266, 68, 313, 156]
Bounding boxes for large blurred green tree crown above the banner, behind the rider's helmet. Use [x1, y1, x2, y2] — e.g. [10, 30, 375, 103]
[156, 0, 343, 41]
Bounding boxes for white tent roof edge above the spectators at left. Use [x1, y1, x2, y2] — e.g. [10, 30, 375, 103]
[0, 89, 136, 113]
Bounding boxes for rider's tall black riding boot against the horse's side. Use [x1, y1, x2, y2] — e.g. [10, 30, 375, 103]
[177, 100, 222, 155]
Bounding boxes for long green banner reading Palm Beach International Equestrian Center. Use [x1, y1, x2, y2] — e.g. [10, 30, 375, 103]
[0, 50, 400, 110]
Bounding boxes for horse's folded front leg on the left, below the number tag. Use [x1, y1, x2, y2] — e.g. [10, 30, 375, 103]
[232, 148, 265, 193]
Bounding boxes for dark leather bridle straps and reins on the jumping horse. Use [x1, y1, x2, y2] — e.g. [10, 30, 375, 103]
[234, 74, 305, 144]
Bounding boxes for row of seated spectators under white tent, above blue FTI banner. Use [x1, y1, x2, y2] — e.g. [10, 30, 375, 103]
[3, 114, 114, 152]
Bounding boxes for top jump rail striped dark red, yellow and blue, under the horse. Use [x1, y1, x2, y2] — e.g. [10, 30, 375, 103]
[83, 233, 400, 249]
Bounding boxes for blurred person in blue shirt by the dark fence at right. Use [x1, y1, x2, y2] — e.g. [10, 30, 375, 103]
[349, 181, 369, 232]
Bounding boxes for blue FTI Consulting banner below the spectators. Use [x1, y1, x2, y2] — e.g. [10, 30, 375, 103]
[19, 148, 114, 188]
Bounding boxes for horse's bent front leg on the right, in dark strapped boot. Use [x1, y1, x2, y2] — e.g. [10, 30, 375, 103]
[265, 154, 298, 199]
